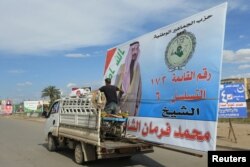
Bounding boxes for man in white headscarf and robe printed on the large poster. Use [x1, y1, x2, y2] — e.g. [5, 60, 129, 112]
[115, 41, 141, 116]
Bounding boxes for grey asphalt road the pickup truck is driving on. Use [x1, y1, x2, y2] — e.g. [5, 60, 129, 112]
[0, 116, 207, 167]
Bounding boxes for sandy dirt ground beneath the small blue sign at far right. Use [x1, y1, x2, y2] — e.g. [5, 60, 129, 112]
[217, 122, 250, 150]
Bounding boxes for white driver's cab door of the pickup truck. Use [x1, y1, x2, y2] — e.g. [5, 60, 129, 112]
[45, 101, 60, 136]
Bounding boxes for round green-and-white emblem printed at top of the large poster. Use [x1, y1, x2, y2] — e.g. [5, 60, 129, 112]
[165, 30, 196, 71]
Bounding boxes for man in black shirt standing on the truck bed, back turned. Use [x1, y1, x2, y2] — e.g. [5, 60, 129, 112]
[99, 78, 123, 114]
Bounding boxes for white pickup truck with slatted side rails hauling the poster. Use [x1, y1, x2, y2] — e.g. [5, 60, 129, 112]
[45, 93, 153, 164]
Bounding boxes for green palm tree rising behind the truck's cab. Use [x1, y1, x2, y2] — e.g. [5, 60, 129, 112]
[42, 86, 61, 106]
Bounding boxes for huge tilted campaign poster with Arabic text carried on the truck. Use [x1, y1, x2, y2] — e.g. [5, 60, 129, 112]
[104, 3, 227, 151]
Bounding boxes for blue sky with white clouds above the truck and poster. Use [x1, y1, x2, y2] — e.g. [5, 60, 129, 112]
[0, 0, 250, 103]
